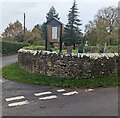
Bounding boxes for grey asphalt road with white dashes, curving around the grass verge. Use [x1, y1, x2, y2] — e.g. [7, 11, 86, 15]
[2, 56, 118, 116]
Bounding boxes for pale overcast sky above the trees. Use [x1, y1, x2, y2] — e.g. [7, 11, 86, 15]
[0, 0, 119, 33]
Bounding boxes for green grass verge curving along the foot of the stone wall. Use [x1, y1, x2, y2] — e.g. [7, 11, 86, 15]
[2, 63, 120, 88]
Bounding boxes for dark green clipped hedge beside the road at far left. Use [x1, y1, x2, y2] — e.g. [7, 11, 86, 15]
[0, 41, 27, 55]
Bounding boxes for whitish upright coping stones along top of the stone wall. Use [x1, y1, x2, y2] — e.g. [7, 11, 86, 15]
[18, 49, 119, 59]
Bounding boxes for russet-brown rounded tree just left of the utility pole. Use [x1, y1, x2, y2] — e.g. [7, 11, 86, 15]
[2, 20, 23, 42]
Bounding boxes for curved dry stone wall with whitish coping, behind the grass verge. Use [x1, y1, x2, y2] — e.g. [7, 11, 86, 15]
[18, 49, 119, 79]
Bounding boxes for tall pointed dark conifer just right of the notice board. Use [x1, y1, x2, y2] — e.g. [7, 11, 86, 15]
[63, 1, 81, 49]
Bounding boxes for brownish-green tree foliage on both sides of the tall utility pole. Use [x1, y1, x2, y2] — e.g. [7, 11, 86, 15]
[2, 20, 45, 45]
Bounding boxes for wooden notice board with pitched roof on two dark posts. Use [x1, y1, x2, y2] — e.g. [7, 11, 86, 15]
[45, 17, 63, 52]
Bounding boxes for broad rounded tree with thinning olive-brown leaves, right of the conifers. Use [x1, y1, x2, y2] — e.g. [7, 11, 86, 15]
[85, 7, 118, 45]
